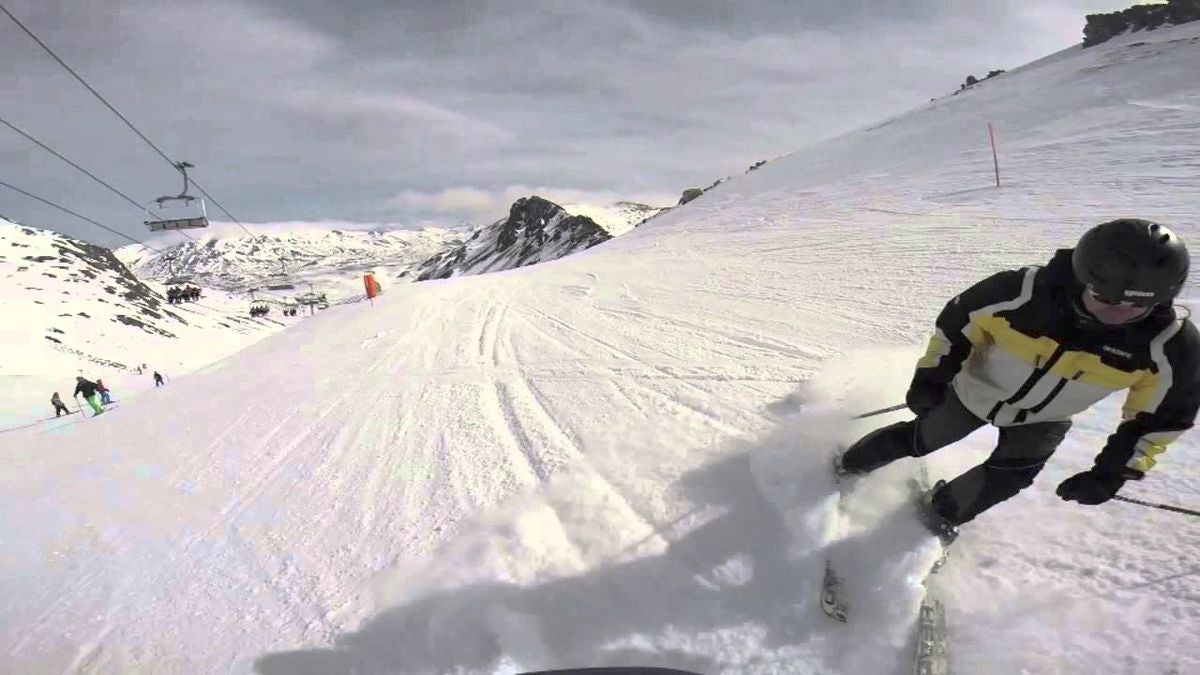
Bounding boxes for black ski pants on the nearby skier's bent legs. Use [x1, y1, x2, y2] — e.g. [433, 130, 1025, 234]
[842, 388, 1070, 525]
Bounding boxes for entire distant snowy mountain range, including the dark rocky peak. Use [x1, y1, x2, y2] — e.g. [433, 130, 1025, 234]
[116, 197, 664, 294]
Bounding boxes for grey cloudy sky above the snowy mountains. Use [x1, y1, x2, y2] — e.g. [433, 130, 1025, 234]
[0, 0, 1132, 245]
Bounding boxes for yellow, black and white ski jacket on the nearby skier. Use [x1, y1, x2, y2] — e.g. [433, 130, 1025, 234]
[912, 249, 1200, 478]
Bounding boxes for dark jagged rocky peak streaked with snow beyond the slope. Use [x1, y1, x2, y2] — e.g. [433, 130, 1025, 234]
[416, 196, 612, 281]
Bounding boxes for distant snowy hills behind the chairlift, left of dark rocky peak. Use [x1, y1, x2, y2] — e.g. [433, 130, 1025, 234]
[116, 225, 464, 300]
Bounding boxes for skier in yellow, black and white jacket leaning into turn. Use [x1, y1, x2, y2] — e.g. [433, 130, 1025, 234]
[839, 219, 1200, 543]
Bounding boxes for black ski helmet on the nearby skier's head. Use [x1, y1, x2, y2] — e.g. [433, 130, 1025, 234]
[1070, 217, 1190, 306]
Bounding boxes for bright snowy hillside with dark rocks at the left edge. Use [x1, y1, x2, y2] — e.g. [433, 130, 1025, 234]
[0, 220, 295, 428]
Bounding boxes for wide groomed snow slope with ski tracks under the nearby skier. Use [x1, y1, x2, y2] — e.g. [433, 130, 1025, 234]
[7, 25, 1200, 674]
